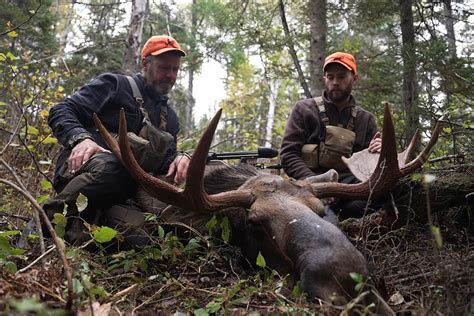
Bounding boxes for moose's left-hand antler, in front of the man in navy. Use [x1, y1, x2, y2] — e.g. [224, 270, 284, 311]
[94, 109, 253, 212]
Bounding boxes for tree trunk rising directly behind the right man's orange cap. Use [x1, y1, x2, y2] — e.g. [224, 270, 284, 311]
[309, 0, 327, 96]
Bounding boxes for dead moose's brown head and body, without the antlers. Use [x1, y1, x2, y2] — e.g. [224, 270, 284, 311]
[138, 165, 368, 301]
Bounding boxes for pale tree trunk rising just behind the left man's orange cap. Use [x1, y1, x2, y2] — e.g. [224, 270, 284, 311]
[122, 0, 148, 74]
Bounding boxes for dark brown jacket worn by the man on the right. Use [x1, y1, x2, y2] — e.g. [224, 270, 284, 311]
[280, 93, 377, 179]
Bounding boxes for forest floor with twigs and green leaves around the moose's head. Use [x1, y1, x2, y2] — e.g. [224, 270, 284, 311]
[0, 164, 474, 315]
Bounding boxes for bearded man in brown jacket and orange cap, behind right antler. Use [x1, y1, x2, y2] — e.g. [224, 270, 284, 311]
[280, 52, 382, 217]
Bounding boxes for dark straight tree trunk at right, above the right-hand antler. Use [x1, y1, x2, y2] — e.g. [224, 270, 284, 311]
[400, 0, 419, 149]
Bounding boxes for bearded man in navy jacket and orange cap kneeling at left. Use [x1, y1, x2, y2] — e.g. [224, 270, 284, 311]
[44, 35, 190, 246]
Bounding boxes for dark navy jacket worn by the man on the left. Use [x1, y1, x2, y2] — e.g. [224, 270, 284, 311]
[48, 73, 179, 173]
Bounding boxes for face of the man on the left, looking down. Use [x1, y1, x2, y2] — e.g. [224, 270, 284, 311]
[143, 53, 181, 95]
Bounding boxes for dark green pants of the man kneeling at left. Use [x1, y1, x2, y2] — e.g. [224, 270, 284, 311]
[43, 153, 149, 249]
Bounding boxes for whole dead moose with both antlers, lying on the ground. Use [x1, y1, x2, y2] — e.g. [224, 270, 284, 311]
[95, 106, 439, 308]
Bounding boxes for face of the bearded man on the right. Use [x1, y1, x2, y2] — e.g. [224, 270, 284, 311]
[324, 63, 355, 103]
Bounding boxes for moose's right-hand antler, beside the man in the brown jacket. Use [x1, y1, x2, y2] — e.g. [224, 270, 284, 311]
[312, 104, 441, 199]
